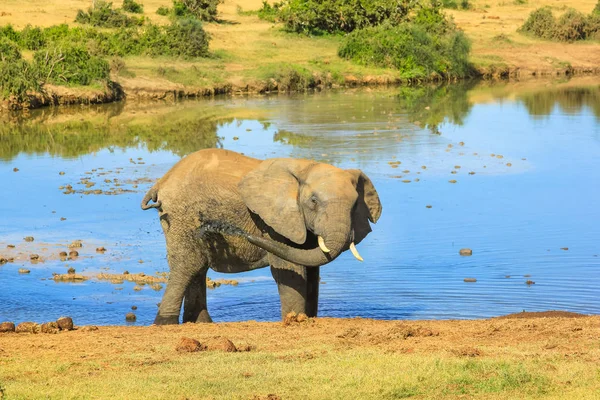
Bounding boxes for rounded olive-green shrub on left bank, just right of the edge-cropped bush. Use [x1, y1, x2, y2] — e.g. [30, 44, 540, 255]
[33, 44, 110, 85]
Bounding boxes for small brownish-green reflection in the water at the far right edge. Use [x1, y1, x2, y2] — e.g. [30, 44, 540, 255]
[518, 87, 600, 120]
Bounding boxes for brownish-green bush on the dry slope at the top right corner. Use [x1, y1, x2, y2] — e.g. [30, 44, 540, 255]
[519, 5, 600, 42]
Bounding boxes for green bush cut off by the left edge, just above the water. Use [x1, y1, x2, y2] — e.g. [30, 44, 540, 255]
[0, 59, 41, 102]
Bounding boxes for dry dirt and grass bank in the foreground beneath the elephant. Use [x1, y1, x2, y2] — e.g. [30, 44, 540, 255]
[0, 313, 600, 400]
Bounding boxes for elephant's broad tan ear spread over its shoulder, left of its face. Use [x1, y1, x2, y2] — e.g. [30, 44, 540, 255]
[238, 158, 311, 244]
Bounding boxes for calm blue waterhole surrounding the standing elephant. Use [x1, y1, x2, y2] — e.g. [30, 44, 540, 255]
[0, 81, 600, 325]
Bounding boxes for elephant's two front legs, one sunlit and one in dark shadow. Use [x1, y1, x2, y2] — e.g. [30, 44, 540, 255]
[270, 257, 319, 319]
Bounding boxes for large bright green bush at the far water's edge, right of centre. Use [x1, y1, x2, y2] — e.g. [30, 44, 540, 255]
[338, 23, 473, 79]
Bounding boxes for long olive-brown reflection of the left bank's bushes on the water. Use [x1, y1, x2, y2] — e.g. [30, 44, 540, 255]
[0, 109, 225, 161]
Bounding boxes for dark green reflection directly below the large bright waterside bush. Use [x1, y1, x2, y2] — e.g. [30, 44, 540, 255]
[398, 81, 475, 134]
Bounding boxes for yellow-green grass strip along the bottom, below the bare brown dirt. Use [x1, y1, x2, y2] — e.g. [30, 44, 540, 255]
[0, 343, 598, 399]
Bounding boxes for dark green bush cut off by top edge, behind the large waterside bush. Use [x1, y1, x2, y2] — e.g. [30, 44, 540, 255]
[278, 0, 416, 35]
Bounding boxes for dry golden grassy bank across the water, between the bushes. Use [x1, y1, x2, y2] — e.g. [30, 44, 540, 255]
[0, 0, 600, 108]
